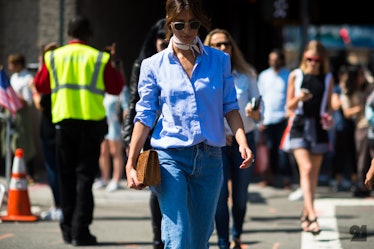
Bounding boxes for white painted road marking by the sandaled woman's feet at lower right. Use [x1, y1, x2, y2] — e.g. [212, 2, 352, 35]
[301, 199, 374, 249]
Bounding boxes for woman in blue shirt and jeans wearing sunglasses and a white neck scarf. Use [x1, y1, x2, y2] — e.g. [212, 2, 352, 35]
[126, 0, 254, 249]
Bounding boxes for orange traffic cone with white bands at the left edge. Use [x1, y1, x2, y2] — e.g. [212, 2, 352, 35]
[1, 148, 38, 221]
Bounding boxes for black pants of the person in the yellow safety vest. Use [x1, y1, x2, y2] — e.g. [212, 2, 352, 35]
[56, 119, 108, 241]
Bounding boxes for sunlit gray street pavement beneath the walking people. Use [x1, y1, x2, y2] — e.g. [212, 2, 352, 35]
[0, 178, 374, 249]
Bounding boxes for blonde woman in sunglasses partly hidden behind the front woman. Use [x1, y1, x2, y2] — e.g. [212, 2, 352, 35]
[204, 29, 261, 249]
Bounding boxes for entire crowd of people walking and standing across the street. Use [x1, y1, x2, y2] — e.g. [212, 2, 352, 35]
[2, 0, 374, 249]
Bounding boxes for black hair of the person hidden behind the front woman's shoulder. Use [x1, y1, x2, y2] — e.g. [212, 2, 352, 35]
[138, 18, 166, 61]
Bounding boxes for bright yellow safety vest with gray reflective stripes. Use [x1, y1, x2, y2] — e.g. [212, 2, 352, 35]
[44, 43, 110, 123]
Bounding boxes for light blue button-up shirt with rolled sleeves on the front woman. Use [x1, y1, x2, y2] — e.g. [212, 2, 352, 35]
[134, 42, 239, 148]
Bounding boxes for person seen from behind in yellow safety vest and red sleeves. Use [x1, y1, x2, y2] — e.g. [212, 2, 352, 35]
[34, 16, 125, 246]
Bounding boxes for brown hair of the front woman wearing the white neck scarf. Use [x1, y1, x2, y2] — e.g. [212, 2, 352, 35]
[165, 0, 211, 40]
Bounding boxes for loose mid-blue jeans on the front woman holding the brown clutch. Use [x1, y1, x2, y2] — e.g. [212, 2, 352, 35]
[151, 143, 223, 249]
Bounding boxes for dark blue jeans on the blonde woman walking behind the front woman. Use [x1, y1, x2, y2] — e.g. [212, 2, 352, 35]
[215, 132, 256, 249]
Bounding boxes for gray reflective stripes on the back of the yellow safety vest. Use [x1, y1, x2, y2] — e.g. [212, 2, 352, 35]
[50, 50, 105, 94]
